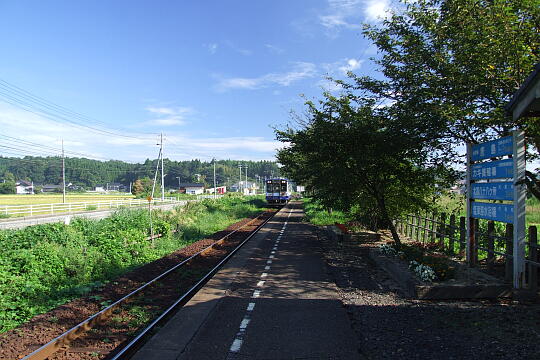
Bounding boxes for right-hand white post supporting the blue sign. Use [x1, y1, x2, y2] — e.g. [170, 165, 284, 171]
[512, 130, 526, 289]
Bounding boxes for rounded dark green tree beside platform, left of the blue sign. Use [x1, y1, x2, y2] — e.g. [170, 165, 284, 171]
[276, 93, 453, 246]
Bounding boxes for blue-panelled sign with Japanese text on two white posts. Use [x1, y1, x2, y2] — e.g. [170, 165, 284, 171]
[467, 130, 526, 288]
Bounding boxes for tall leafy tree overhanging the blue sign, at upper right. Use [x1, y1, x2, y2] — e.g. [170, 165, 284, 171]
[350, 0, 540, 196]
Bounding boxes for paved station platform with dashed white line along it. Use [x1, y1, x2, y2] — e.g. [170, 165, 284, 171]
[133, 202, 360, 360]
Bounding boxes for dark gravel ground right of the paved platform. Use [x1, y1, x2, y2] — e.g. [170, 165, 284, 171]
[319, 230, 540, 359]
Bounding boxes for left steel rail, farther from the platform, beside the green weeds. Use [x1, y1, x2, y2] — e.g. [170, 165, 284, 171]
[22, 208, 277, 360]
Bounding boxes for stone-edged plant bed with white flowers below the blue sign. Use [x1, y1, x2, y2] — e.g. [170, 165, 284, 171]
[370, 236, 512, 300]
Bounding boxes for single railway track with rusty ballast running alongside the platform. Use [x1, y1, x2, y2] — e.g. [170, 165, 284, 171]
[17, 210, 277, 360]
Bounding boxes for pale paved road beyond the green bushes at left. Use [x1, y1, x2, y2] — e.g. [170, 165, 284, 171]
[0, 201, 186, 229]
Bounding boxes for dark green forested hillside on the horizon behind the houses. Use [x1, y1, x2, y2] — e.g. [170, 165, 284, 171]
[0, 156, 279, 188]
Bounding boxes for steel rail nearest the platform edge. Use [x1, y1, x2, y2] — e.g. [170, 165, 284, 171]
[111, 205, 279, 360]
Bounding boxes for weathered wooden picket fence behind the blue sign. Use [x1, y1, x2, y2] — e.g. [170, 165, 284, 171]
[396, 213, 540, 291]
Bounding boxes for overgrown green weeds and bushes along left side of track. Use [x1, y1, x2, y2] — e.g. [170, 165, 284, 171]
[0, 197, 265, 332]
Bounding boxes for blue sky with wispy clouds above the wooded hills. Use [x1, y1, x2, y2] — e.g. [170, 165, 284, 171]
[0, 0, 389, 162]
